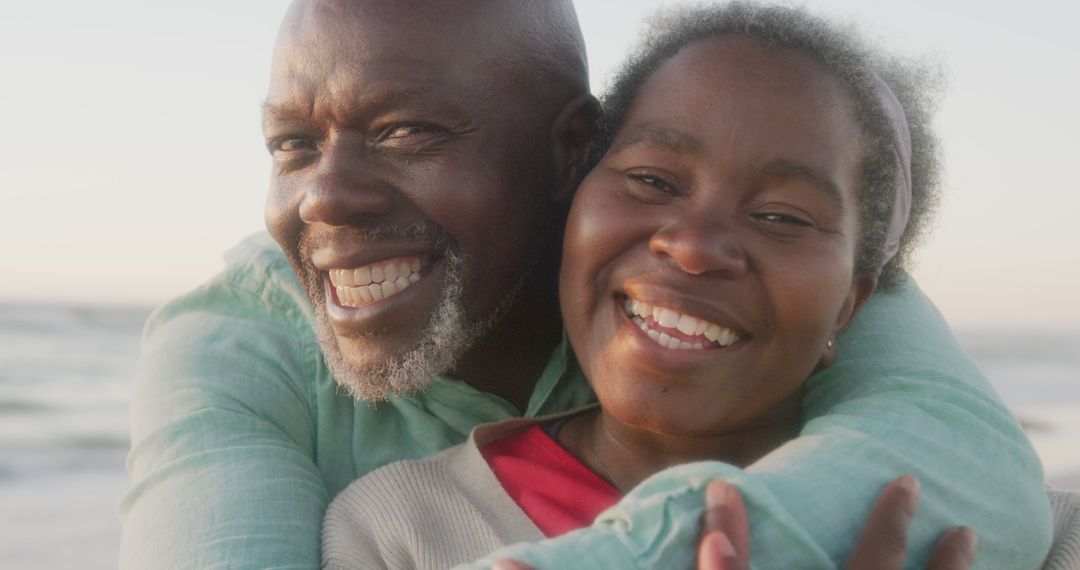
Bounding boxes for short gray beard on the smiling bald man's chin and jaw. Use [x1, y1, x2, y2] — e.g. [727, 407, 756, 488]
[315, 250, 525, 403]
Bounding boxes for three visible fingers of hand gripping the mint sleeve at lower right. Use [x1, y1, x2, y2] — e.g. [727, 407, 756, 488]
[699, 477, 976, 570]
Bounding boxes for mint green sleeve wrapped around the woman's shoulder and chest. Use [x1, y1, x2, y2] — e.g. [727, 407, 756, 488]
[460, 274, 1051, 570]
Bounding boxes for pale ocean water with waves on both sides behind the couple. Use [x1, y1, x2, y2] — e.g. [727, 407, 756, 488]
[0, 306, 1080, 570]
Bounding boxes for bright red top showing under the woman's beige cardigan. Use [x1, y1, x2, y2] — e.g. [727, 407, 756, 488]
[481, 425, 622, 538]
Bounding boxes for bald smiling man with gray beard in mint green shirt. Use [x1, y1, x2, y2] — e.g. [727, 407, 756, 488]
[120, 0, 1049, 569]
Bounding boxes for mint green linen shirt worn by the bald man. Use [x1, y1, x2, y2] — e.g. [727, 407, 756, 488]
[120, 234, 1051, 570]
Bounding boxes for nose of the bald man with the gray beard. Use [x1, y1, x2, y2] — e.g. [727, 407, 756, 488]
[299, 145, 393, 226]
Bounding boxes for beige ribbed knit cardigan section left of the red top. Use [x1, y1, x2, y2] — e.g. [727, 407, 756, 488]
[323, 421, 543, 568]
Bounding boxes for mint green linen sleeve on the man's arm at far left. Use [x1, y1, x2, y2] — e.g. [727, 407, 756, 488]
[120, 242, 329, 570]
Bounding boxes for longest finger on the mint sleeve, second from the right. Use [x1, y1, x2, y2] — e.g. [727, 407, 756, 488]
[848, 476, 919, 570]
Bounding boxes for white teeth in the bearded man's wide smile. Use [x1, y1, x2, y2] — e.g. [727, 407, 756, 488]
[329, 257, 423, 307]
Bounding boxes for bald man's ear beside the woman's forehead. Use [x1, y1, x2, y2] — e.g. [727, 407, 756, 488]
[551, 93, 600, 204]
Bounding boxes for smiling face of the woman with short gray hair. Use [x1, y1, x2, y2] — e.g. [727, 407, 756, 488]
[562, 38, 877, 451]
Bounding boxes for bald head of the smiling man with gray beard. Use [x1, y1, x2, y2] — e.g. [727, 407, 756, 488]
[265, 2, 595, 408]
